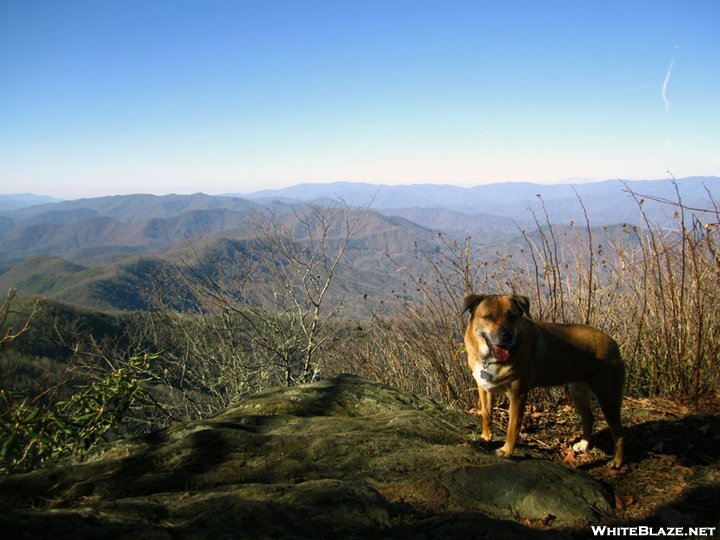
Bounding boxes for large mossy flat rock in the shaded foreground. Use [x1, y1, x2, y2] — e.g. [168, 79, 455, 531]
[0, 376, 612, 540]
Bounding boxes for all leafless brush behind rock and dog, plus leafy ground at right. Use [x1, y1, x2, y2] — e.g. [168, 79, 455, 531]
[3, 178, 720, 536]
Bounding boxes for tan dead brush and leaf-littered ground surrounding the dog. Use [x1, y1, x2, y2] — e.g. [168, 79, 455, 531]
[342, 179, 720, 526]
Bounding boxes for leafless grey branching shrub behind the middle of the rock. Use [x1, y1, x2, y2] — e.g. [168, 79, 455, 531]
[127, 205, 362, 418]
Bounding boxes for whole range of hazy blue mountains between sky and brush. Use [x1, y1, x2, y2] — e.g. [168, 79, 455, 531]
[0, 177, 720, 309]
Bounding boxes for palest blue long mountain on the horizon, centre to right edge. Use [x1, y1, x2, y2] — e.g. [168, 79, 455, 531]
[244, 176, 720, 226]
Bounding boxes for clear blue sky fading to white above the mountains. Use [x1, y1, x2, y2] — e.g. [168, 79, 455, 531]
[0, 0, 720, 198]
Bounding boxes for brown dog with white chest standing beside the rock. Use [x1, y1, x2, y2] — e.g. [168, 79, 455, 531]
[465, 294, 625, 468]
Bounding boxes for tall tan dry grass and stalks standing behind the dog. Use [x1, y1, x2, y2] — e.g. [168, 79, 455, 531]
[348, 180, 720, 406]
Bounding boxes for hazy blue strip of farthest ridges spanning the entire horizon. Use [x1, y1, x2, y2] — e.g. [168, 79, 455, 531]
[0, 176, 720, 228]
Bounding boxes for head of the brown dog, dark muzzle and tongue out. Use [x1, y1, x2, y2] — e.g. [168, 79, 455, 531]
[464, 294, 530, 362]
